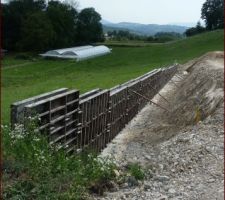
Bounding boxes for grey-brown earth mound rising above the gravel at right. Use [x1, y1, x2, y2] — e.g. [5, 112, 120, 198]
[167, 52, 224, 125]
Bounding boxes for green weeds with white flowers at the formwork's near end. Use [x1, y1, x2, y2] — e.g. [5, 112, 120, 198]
[2, 121, 147, 200]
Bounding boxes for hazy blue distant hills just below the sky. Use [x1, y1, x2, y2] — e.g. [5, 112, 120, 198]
[102, 20, 188, 36]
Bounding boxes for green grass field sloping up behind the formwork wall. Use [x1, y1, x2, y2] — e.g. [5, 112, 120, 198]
[1, 30, 224, 123]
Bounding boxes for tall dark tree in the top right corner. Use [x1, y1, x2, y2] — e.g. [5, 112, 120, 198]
[201, 0, 224, 30]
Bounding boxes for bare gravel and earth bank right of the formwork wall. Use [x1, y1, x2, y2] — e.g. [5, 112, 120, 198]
[94, 52, 224, 200]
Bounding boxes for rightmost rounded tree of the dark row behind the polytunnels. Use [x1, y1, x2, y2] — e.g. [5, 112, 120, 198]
[77, 8, 104, 43]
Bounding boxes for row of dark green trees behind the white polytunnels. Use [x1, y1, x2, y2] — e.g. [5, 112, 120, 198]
[2, 0, 104, 51]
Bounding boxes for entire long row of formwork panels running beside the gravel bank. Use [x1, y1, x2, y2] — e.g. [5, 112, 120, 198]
[11, 65, 177, 153]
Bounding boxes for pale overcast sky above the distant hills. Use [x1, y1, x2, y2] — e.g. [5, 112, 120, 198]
[77, 0, 206, 24]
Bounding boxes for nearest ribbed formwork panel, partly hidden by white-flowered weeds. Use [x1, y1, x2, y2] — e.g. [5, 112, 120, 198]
[24, 90, 79, 153]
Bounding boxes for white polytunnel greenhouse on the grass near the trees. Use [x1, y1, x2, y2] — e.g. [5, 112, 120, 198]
[40, 45, 111, 61]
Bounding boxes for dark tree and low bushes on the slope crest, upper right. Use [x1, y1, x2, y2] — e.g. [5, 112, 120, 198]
[185, 0, 224, 36]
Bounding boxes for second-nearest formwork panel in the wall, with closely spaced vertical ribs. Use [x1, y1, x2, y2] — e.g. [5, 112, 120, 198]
[78, 90, 109, 151]
